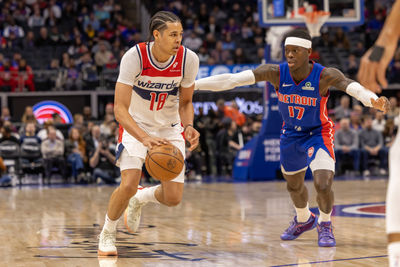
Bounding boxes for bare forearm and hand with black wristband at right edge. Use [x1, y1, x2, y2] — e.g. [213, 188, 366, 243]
[357, 0, 400, 93]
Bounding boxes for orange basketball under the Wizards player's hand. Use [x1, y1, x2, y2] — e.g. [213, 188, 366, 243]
[145, 144, 184, 182]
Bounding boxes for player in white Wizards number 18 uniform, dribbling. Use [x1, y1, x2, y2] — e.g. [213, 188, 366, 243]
[98, 11, 200, 256]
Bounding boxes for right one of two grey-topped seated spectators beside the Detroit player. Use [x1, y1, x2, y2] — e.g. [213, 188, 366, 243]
[359, 115, 387, 176]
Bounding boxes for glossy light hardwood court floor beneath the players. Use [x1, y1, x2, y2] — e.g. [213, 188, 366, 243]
[0, 179, 387, 267]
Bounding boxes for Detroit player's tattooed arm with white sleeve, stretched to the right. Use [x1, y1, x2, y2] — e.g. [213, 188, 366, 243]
[320, 68, 390, 114]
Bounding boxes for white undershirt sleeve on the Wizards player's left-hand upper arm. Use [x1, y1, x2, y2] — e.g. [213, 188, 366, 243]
[117, 46, 141, 86]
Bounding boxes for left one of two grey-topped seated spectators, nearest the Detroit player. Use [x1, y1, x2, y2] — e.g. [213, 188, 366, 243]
[335, 118, 360, 174]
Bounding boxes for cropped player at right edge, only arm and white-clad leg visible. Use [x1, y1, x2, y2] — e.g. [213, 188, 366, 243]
[358, 0, 400, 267]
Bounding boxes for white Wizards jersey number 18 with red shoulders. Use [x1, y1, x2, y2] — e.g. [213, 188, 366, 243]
[118, 43, 198, 148]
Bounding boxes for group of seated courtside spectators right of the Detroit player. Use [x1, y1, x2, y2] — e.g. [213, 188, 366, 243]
[331, 95, 400, 176]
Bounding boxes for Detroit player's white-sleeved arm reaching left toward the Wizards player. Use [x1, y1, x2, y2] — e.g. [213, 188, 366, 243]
[195, 64, 279, 91]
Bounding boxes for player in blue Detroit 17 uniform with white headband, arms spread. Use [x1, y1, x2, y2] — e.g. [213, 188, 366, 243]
[195, 29, 389, 247]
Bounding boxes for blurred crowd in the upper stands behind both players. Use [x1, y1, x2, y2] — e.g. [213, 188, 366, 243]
[0, 0, 400, 91]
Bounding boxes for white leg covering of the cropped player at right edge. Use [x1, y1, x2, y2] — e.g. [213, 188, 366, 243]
[386, 131, 400, 234]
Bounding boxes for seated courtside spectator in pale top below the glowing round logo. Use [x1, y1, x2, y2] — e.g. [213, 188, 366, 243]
[41, 126, 66, 179]
